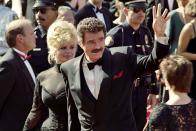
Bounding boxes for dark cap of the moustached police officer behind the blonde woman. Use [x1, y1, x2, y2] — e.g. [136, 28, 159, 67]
[33, 0, 64, 8]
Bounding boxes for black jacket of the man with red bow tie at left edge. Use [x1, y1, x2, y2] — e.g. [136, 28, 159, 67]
[0, 49, 35, 131]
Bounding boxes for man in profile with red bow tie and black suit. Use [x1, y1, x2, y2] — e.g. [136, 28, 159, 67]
[0, 19, 36, 131]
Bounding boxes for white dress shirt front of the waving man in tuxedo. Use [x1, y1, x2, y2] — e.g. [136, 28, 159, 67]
[82, 58, 103, 99]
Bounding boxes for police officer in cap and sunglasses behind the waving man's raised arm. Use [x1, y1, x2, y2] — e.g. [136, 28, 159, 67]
[105, 0, 158, 131]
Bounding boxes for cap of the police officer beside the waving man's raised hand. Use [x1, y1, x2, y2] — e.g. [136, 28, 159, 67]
[125, 0, 147, 8]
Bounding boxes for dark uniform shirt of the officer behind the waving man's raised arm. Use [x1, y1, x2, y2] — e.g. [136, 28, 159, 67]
[106, 22, 153, 54]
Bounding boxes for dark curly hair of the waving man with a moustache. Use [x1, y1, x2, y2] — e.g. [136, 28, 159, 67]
[77, 17, 106, 42]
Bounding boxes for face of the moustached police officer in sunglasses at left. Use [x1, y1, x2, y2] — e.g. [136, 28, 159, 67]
[33, 6, 58, 30]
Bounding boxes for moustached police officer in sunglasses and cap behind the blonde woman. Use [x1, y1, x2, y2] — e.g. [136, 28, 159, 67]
[29, 0, 64, 75]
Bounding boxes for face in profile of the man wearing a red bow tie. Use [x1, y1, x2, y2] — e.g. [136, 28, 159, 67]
[23, 25, 36, 52]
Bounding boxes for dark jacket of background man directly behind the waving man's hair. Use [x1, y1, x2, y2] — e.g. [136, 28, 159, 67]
[75, 3, 114, 31]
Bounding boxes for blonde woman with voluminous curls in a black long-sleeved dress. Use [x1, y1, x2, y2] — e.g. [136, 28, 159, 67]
[24, 20, 77, 131]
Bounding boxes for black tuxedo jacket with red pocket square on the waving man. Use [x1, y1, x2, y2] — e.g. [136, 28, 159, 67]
[61, 41, 168, 131]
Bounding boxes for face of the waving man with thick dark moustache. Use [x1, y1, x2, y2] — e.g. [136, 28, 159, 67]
[80, 31, 105, 62]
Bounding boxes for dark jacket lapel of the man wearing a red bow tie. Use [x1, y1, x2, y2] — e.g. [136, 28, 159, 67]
[12, 50, 35, 89]
